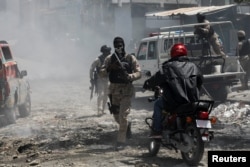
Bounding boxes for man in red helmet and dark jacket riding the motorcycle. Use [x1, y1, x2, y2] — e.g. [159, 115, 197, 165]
[143, 43, 203, 138]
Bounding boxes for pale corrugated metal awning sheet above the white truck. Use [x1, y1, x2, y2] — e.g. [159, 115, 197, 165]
[146, 4, 235, 17]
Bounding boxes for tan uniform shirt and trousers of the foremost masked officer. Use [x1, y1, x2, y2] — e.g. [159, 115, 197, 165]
[102, 39, 141, 143]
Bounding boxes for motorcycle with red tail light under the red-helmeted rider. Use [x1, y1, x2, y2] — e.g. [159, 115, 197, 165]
[145, 87, 216, 166]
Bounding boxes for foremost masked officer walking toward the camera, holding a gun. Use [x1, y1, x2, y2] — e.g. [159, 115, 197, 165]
[102, 37, 141, 149]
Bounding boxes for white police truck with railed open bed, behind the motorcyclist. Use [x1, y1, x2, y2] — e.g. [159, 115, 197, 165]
[135, 21, 245, 101]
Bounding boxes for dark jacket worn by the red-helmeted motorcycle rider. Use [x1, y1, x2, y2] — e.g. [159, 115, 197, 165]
[144, 56, 203, 111]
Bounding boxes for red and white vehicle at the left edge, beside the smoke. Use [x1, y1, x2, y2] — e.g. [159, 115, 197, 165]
[0, 41, 31, 124]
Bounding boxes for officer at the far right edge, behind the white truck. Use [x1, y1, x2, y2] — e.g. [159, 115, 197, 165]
[237, 30, 250, 90]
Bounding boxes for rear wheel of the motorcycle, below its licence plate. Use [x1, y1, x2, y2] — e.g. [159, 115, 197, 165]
[181, 125, 204, 166]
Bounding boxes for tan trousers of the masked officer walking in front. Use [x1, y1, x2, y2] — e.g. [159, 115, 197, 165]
[110, 84, 134, 143]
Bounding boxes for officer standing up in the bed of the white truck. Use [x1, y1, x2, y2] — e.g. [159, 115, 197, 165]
[194, 13, 226, 58]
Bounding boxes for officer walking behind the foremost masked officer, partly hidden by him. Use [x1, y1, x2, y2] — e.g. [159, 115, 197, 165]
[89, 45, 111, 116]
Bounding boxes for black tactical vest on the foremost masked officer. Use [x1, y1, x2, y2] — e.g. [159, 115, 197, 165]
[109, 54, 133, 83]
